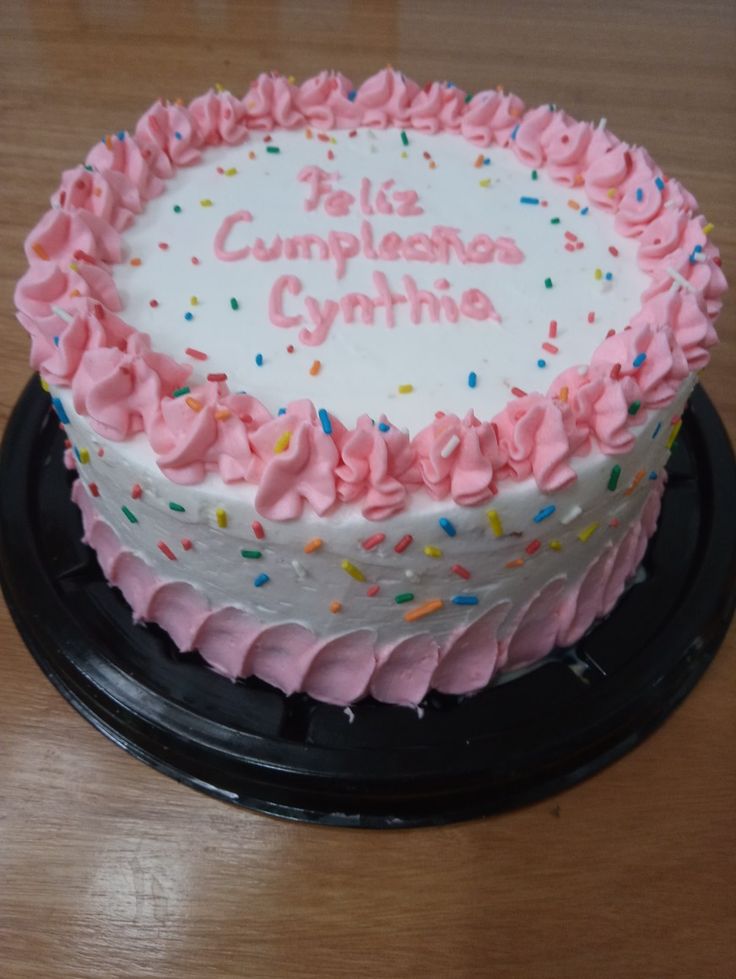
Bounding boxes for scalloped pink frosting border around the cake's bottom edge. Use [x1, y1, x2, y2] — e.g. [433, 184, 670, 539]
[72, 479, 665, 706]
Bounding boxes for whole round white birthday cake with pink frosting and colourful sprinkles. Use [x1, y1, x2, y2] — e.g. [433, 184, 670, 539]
[16, 69, 726, 705]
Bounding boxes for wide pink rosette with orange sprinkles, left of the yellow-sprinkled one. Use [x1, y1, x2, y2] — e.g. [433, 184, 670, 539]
[150, 381, 271, 485]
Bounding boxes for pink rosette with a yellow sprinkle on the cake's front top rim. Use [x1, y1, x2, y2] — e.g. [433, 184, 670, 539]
[250, 400, 338, 520]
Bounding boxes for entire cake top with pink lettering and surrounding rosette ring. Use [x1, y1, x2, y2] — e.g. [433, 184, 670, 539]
[16, 69, 726, 519]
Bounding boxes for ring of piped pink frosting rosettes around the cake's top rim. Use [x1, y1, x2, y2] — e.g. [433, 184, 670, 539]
[15, 69, 726, 520]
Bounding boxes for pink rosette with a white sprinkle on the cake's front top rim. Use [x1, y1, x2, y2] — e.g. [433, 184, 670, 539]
[414, 411, 506, 506]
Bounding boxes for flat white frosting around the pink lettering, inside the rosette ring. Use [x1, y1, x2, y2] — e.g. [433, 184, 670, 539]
[114, 129, 647, 430]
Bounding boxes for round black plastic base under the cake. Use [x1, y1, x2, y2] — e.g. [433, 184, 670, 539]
[0, 380, 736, 827]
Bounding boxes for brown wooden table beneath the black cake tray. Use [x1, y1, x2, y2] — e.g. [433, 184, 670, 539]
[0, 0, 736, 979]
